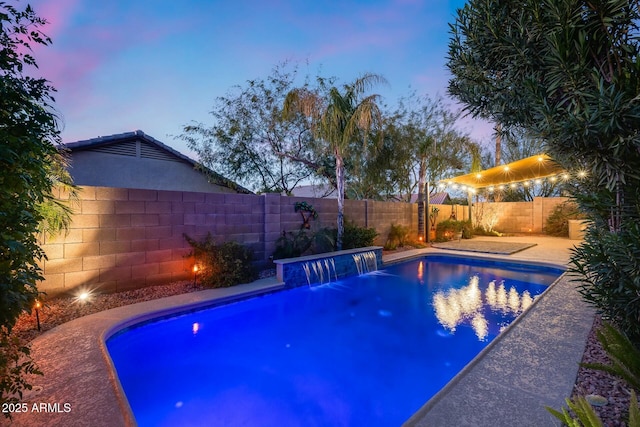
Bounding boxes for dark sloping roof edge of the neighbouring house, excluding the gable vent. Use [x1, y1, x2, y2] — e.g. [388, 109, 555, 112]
[64, 130, 253, 194]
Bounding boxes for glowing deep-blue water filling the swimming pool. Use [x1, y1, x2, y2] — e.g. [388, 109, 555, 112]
[107, 257, 562, 427]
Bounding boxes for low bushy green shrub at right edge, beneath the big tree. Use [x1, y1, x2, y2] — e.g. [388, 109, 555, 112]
[568, 220, 640, 346]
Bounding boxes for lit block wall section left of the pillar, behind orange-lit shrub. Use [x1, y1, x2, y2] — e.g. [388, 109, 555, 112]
[38, 187, 265, 294]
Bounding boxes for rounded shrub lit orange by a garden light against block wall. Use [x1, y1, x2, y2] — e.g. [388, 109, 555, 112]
[184, 233, 258, 288]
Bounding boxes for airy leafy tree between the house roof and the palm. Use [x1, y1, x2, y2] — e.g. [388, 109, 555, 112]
[180, 63, 320, 194]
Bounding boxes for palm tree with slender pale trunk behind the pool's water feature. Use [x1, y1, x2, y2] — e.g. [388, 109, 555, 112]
[284, 74, 386, 250]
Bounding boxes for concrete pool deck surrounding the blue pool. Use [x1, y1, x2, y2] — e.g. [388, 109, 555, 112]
[10, 236, 594, 427]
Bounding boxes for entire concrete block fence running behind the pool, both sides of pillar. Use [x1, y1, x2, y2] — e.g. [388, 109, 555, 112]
[38, 187, 568, 295]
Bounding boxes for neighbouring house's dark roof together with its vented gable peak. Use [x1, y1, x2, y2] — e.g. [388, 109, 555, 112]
[64, 130, 253, 194]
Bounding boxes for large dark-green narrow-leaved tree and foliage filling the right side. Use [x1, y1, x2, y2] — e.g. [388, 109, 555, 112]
[448, 0, 640, 342]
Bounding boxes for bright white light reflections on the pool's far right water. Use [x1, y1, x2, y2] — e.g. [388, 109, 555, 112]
[433, 276, 533, 341]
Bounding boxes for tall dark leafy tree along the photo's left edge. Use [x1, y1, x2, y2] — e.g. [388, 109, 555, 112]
[0, 1, 70, 412]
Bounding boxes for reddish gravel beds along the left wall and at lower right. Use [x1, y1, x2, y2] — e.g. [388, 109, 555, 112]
[8, 270, 630, 427]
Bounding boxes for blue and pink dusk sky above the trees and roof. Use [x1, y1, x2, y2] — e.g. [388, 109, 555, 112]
[26, 0, 492, 156]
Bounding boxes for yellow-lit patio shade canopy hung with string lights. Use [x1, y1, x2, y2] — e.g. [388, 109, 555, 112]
[442, 154, 564, 189]
